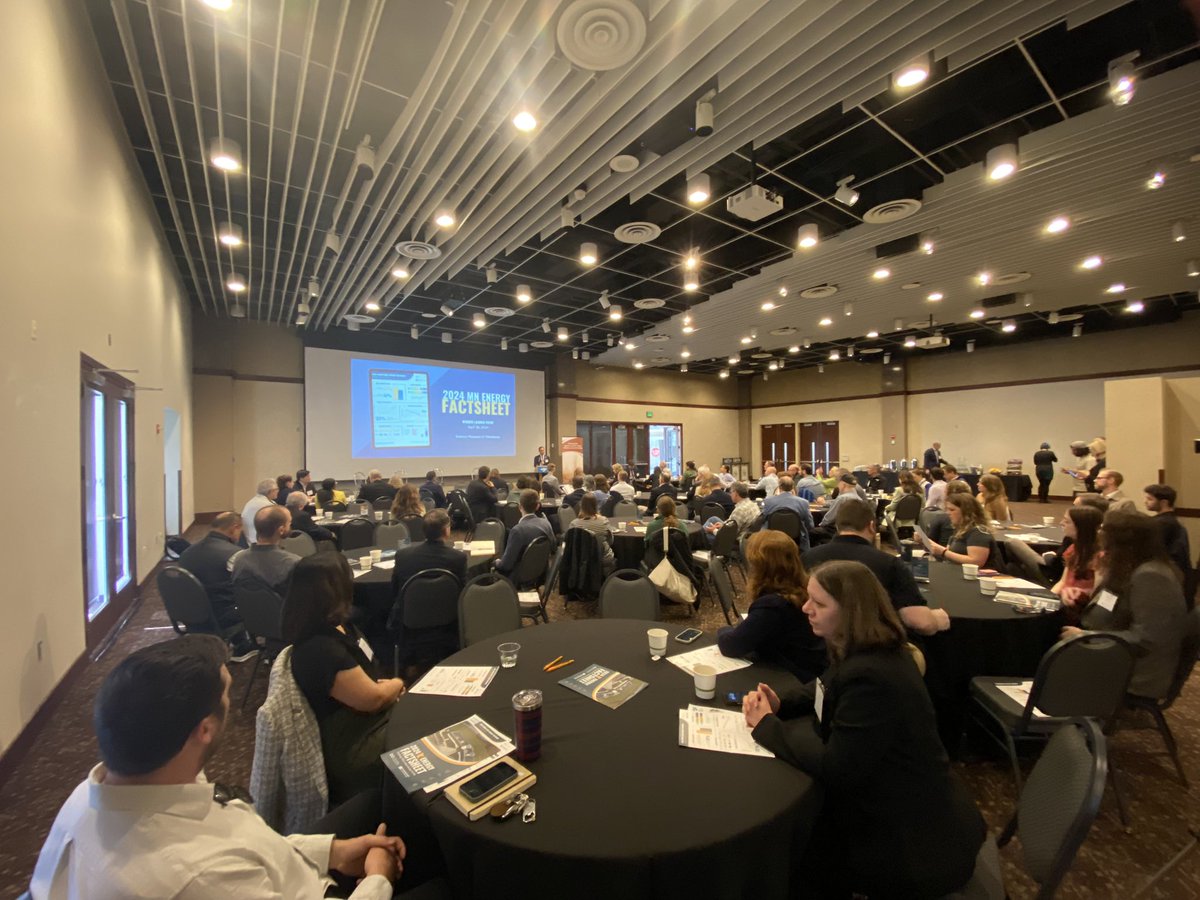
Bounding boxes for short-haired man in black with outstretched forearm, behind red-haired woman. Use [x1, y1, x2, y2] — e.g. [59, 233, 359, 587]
[803, 501, 950, 635]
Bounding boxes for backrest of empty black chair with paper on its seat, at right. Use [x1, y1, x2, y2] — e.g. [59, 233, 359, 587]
[1025, 632, 1133, 721]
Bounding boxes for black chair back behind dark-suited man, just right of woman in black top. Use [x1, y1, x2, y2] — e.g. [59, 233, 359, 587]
[388, 569, 462, 676]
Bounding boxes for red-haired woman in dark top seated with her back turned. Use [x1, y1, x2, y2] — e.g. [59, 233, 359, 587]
[716, 532, 828, 682]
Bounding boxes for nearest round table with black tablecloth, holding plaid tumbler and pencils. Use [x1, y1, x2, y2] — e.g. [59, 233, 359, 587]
[385, 619, 820, 900]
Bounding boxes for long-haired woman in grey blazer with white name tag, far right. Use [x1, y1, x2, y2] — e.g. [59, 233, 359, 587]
[1062, 510, 1187, 700]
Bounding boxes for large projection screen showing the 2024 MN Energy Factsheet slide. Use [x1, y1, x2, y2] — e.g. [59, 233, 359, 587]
[305, 347, 546, 479]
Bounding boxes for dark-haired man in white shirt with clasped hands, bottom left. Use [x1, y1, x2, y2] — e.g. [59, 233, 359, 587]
[30, 635, 406, 900]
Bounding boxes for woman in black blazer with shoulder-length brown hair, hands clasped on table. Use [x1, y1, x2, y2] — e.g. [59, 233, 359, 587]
[743, 560, 986, 898]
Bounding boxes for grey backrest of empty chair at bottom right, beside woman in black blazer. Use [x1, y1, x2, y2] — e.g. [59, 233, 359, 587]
[1016, 719, 1109, 898]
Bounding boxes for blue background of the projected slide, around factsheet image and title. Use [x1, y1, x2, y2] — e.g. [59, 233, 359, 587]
[350, 359, 517, 458]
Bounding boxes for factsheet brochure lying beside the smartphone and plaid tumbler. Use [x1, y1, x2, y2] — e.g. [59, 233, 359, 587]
[382, 715, 516, 793]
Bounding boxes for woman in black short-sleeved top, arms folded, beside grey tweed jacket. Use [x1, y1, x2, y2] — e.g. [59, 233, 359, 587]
[283, 553, 404, 805]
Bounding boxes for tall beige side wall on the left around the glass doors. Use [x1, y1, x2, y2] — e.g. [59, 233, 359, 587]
[0, 0, 193, 750]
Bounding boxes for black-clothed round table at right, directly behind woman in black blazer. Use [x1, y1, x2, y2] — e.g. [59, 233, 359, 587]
[920, 562, 1066, 755]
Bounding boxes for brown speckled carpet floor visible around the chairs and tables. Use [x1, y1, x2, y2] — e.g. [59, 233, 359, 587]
[0, 504, 1200, 899]
